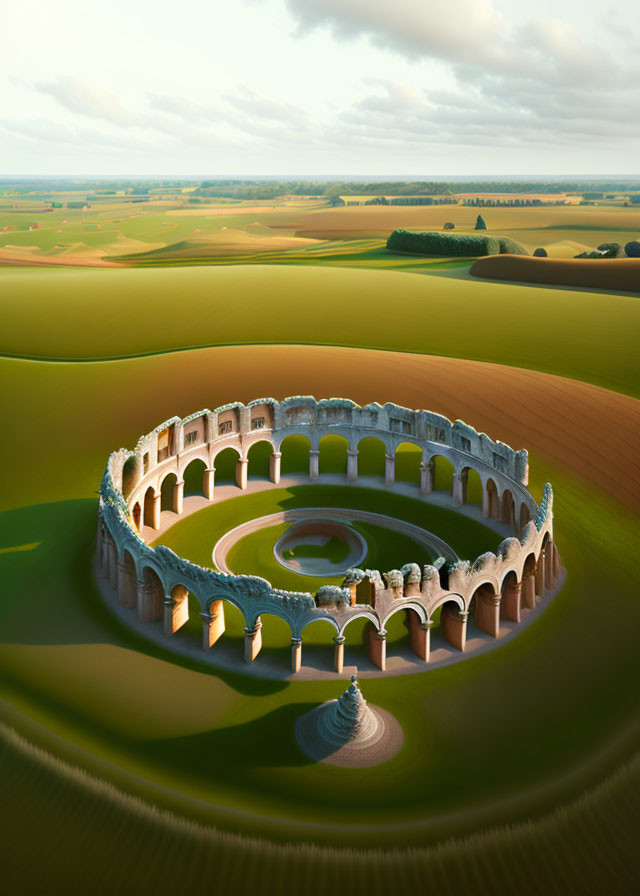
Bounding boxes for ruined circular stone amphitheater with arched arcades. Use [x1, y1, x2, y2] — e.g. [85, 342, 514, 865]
[96, 396, 563, 674]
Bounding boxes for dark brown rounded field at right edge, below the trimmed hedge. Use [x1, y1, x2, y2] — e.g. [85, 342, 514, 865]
[470, 255, 640, 295]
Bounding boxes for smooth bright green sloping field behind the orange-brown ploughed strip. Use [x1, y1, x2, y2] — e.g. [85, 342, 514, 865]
[0, 265, 640, 396]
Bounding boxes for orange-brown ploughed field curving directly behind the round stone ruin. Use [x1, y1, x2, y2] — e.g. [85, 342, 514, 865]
[125, 345, 640, 512]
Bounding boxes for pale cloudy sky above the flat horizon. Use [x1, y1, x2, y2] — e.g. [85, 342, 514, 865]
[0, 0, 640, 177]
